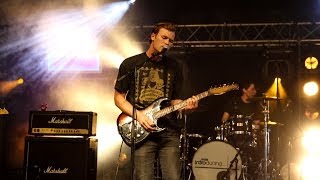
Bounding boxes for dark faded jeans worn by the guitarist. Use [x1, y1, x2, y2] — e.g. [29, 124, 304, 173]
[135, 130, 181, 180]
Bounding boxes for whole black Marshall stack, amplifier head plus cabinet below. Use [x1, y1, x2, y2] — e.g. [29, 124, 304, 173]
[24, 110, 98, 180]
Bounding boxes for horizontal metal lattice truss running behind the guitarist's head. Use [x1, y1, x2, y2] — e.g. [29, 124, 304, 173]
[117, 22, 320, 47]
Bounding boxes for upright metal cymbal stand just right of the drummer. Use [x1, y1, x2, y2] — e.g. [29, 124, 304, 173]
[262, 99, 270, 180]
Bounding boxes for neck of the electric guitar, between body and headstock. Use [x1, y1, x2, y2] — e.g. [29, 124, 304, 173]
[154, 91, 209, 119]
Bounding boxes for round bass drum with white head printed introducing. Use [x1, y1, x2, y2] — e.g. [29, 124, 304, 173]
[192, 141, 242, 180]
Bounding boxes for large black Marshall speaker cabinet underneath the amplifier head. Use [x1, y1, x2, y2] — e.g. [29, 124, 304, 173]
[24, 136, 98, 180]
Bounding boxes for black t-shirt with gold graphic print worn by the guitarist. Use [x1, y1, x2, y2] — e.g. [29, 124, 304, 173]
[115, 53, 184, 129]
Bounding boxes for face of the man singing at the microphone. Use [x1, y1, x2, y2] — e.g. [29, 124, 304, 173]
[151, 28, 175, 52]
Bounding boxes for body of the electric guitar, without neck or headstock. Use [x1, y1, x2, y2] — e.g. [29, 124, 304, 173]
[117, 98, 168, 146]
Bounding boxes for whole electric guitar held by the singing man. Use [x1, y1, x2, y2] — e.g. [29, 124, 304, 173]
[117, 83, 239, 146]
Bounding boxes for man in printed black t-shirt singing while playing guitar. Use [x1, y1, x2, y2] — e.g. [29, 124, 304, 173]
[114, 22, 198, 180]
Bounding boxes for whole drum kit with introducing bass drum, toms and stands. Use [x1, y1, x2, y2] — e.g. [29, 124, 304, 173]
[180, 97, 283, 180]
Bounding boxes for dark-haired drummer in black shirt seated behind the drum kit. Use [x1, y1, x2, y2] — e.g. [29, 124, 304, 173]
[221, 80, 262, 133]
